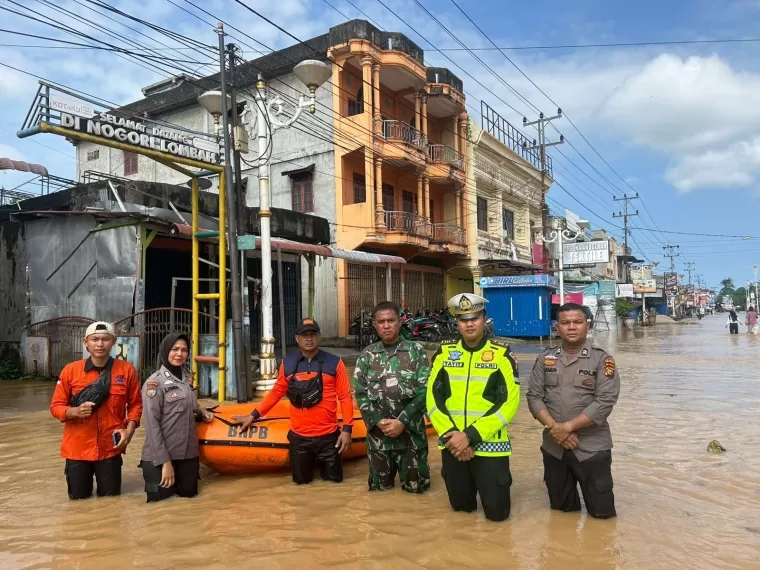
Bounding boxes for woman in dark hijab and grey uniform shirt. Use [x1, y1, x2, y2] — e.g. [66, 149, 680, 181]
[140, 333, 214, 503]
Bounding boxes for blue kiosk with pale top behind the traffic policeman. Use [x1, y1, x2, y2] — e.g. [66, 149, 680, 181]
[480, 275, 558, 338]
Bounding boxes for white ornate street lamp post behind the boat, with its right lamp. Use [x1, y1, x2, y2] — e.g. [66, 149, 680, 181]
[241, 60, 332, 390]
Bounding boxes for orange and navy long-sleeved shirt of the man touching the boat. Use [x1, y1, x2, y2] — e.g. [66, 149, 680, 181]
[255, 350, 354, 437]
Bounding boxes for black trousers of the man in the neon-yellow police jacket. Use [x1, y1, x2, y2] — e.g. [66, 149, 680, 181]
[441, 449, 512, 521]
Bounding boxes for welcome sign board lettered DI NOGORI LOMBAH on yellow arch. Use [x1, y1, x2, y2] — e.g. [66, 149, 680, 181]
[61, 112, 219, 164]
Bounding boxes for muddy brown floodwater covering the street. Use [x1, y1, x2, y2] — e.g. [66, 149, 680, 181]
[0, 315, 760, 570]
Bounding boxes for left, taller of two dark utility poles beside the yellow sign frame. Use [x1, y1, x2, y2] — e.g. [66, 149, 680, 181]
[216, 22, 248, 403]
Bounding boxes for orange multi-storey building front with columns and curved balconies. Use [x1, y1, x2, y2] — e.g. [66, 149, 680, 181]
[327, 21, 472, 335]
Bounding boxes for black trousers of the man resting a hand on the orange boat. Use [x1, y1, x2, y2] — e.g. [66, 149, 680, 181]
[288, 430, 343, 485]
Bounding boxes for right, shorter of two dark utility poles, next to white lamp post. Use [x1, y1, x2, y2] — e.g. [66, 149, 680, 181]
[227, 44, 253, 401]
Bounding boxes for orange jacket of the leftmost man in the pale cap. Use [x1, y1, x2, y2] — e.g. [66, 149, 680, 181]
[50, 359, 142, 461]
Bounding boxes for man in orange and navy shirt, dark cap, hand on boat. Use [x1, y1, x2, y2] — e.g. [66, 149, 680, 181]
[232, 319, 354, 485]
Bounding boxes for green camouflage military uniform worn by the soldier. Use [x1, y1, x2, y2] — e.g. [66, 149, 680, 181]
[353, 340, 430, 493]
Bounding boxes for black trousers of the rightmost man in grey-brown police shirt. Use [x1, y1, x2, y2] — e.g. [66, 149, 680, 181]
[541, 449, 616, 519]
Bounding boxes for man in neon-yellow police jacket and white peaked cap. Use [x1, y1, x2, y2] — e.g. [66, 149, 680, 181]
[427, 293, 520, 521]
